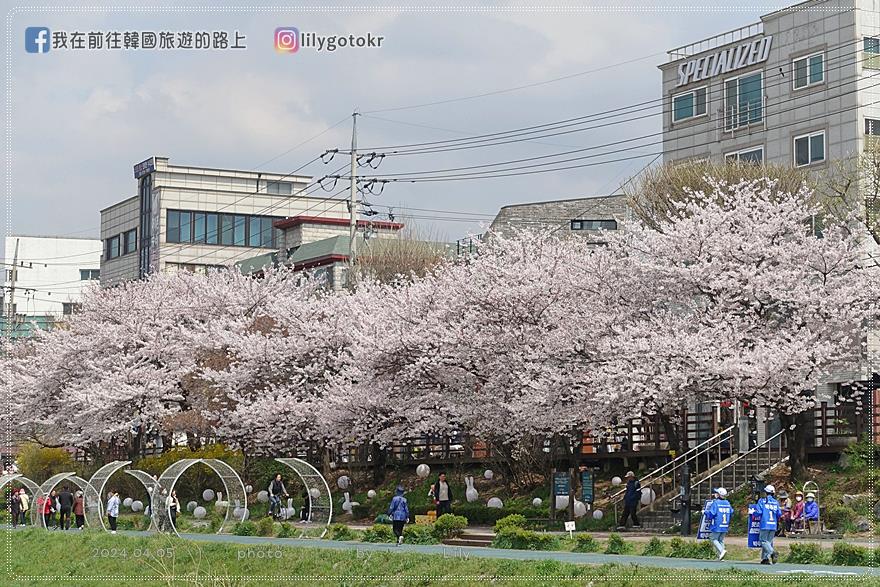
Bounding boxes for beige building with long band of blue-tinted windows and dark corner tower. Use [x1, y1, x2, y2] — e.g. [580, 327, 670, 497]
[101, 157, 348, 285]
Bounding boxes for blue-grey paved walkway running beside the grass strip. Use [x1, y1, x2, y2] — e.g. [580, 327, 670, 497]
[124, 531, 880, 577]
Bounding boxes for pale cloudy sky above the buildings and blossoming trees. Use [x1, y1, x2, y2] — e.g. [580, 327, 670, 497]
[0, 0, 792, 260]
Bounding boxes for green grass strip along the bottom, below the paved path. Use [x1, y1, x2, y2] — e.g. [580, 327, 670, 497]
[3, 529, 864, 587]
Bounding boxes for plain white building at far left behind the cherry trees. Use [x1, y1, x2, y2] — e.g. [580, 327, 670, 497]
[0, 235, 101, 336]
